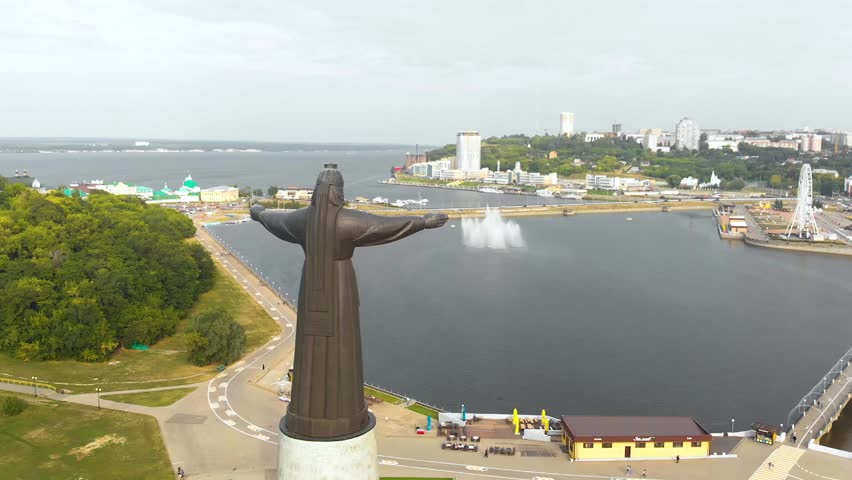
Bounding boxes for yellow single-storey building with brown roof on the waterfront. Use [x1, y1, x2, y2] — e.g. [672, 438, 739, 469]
[560, 415, 712, 460]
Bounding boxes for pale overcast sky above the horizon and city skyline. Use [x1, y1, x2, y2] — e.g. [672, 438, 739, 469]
[0, 0, 852, 144]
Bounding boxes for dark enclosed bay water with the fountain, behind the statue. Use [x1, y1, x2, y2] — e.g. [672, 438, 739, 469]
[214, 212, 852, 438]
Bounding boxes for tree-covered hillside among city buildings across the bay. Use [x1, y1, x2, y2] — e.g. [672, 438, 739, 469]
[427, 134, 852, 195]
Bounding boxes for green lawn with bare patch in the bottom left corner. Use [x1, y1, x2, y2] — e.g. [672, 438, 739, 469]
[0, 395, 175, 480]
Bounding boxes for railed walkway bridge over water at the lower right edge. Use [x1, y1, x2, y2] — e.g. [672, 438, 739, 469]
[787, 348, 852, 448]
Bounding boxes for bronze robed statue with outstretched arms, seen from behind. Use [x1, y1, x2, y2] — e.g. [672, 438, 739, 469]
[251, 164, 447, 440]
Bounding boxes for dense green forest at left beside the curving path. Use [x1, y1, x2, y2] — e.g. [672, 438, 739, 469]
[0, 183, 214, 361]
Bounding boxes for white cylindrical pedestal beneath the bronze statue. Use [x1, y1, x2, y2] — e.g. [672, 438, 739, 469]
[278, 413, 379, 480]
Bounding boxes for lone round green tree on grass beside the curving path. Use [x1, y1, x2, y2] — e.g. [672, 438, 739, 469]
[185, 310, 246, 365]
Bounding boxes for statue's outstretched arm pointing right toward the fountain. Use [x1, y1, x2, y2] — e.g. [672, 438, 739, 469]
[351, 211, 447, 247]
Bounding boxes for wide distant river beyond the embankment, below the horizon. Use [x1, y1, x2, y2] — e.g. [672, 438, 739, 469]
[0, 150, 566, 208]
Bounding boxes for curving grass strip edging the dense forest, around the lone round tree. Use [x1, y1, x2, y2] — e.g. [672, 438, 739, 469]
[0, 263, 280, 393]
